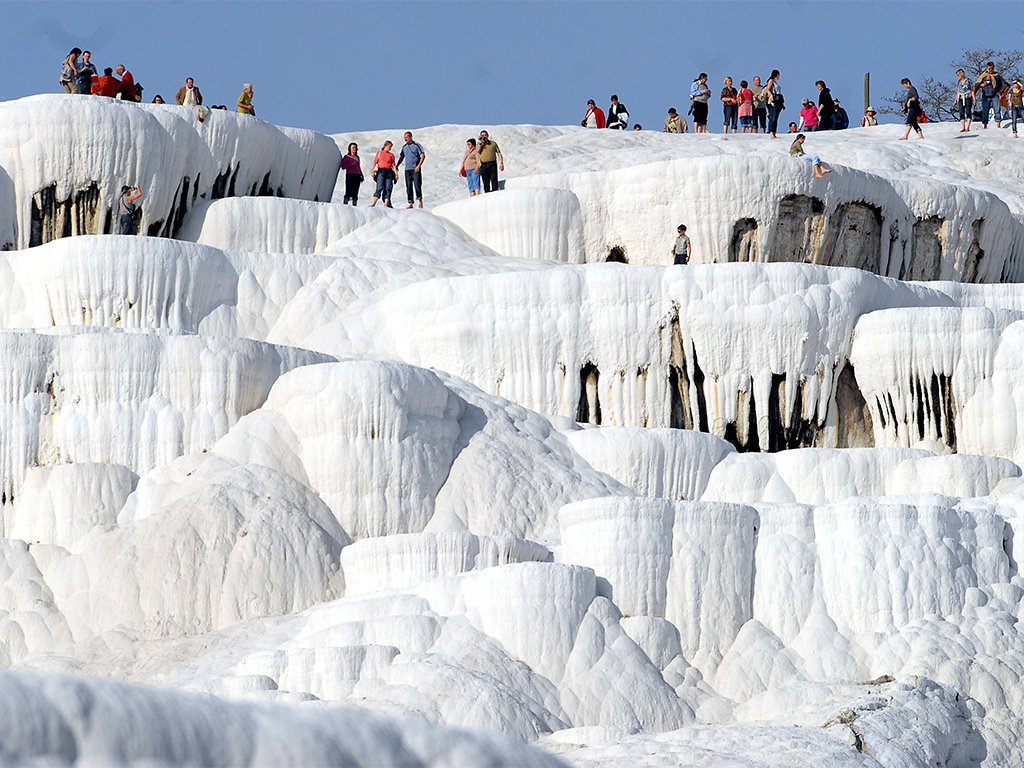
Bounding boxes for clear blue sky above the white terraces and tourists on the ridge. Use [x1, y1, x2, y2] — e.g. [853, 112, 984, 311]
[8, 0, 1024, 133]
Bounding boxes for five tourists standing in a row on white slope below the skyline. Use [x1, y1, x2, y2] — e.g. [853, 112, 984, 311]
[341, 130, 505, 208]
